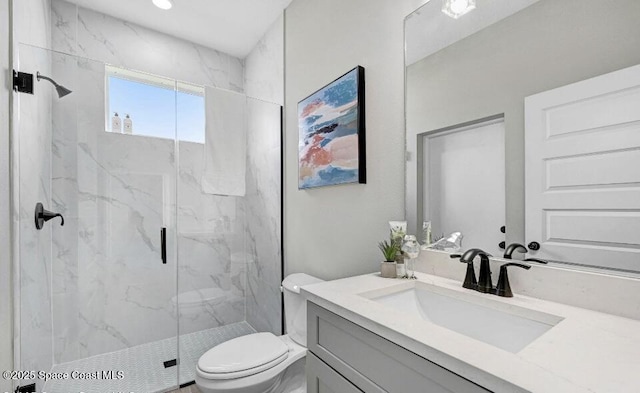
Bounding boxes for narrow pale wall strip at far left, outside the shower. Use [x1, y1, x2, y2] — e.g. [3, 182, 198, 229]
[0, 0, 13, 392]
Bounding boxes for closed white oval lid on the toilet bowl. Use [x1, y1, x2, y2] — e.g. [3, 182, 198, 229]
[198, 333, 289, 379]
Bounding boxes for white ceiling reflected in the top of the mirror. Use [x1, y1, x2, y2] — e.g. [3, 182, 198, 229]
[405, 0, 539, 65]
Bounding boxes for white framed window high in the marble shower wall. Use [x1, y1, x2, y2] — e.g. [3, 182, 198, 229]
[105, 65, 205, 143]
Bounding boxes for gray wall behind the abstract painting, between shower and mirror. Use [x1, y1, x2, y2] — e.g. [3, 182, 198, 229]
[285, 0, 424, 279]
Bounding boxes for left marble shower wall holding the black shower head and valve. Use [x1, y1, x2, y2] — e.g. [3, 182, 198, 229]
[12, 0, 53, 387]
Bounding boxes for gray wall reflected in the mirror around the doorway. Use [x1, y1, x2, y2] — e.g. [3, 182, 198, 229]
[407, 0, 640, 242]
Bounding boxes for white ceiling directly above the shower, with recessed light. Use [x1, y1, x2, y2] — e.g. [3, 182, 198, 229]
[70, 0, 291, 59]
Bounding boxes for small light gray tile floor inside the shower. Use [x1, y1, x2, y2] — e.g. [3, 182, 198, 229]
[43, 322, 255, 393]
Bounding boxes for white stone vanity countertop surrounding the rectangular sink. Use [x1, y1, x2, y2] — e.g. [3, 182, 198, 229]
[302, 273, 640, 393]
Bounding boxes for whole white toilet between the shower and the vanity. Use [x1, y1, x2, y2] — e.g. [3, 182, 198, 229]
[196, 273, 322, 393]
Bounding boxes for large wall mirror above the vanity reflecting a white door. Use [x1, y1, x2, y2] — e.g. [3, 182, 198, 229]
[405, 0, 640, 275]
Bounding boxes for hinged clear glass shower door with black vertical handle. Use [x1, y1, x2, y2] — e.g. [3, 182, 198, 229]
[14, 45, 178, 393]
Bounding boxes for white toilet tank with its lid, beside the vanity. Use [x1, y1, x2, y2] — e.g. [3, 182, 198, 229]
[282, 273, 323, 347]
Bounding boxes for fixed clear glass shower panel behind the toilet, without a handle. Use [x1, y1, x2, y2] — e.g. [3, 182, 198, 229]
[177, 83, 283, 384]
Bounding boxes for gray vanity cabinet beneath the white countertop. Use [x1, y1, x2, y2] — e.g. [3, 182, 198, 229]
[307, 302, 488, 393]
